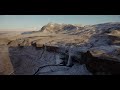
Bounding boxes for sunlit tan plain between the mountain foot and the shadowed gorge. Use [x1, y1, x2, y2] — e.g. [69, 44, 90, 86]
[0, 32, 91, 45]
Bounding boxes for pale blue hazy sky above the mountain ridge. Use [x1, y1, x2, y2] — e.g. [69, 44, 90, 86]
[0, 15, 120, 29]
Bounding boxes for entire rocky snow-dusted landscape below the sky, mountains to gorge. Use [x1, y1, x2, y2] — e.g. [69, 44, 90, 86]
[0, 22, 120, 75]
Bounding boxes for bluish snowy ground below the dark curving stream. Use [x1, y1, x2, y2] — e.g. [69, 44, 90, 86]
[38, 63, 92, 75]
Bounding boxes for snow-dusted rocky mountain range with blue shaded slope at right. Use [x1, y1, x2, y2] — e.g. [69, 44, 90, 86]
[40, 22, 120, 47]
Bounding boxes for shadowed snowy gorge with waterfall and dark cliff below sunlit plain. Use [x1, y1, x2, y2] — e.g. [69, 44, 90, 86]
[9, 43, 120, 75]
